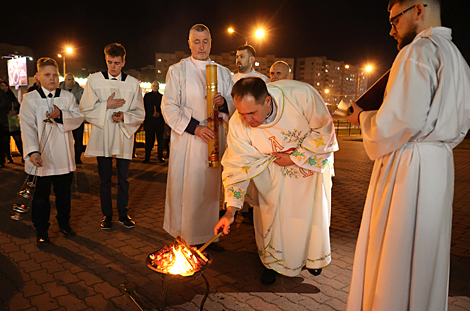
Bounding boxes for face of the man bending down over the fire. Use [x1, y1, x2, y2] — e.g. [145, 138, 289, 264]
[234, 95, 271, 127]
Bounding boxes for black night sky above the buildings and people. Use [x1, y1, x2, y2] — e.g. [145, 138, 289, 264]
[4, 0, 470, 80]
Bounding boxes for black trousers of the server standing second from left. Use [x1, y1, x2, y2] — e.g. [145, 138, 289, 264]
[96, 157, 131, 218]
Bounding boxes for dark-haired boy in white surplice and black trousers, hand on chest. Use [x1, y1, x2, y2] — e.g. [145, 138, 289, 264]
[80, 43, 145, 230]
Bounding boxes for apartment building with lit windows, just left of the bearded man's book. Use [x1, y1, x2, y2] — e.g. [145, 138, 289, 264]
[295, 56, 368, 105]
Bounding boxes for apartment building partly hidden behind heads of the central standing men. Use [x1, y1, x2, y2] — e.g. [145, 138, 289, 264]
[155, 51, 295, 83]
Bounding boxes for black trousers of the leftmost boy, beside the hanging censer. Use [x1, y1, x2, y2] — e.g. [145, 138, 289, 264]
[31, 172, 73, 234]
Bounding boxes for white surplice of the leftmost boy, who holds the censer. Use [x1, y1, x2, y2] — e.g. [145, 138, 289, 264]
[20, 88, 83, 176]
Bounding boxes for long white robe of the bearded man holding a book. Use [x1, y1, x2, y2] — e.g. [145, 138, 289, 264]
[348, 27, 470, 311]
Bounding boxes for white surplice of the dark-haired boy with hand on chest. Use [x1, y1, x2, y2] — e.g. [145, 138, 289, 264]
[80, 71, 145, 160]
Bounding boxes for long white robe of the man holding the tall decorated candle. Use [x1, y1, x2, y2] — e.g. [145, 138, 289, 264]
[162, 57, 235, 245]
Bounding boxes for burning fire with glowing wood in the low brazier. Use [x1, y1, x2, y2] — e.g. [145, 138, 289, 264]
[149, 245, 205, 276]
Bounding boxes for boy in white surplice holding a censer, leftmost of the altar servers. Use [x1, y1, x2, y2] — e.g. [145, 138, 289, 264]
[20, 57, 83, 245]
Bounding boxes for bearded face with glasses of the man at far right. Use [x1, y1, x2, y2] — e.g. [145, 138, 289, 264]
[390, 3, 418, 50]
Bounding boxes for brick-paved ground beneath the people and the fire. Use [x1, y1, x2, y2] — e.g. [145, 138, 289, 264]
[0, 136, 470, 311]
